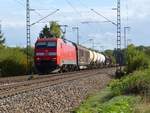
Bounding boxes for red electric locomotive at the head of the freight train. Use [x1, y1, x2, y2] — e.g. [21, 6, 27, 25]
[34, 38, 77, 73]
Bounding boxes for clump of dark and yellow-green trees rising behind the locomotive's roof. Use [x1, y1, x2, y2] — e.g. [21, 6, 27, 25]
[39, 21, 62, 38]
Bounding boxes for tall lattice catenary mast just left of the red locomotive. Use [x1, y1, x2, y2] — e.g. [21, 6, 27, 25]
[26, 0, 32, 75]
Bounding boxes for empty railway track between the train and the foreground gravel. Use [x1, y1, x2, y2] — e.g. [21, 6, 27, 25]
[0, 69, 115, 98]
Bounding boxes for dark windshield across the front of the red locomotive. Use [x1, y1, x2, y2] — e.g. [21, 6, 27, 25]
[35, 42, 56, 48]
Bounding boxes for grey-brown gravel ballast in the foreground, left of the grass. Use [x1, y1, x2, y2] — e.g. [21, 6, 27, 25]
[0, 74, 111, 113]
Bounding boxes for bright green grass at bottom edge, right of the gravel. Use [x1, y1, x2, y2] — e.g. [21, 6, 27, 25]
[73, 88, 139, 113]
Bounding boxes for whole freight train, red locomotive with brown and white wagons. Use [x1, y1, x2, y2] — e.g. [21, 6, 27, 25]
[34, 38, 111, 73]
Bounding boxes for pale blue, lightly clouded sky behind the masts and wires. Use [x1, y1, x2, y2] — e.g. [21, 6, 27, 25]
[0, 0, 150, 51]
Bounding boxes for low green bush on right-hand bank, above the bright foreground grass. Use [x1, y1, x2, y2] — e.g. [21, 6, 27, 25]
[110, 69, 150, 95]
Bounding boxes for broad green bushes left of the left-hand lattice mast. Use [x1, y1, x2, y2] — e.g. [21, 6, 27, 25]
[0, 48, 27, 76]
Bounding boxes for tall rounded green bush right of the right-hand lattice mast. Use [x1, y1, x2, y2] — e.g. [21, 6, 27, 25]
[125, 45, 149, 73]
